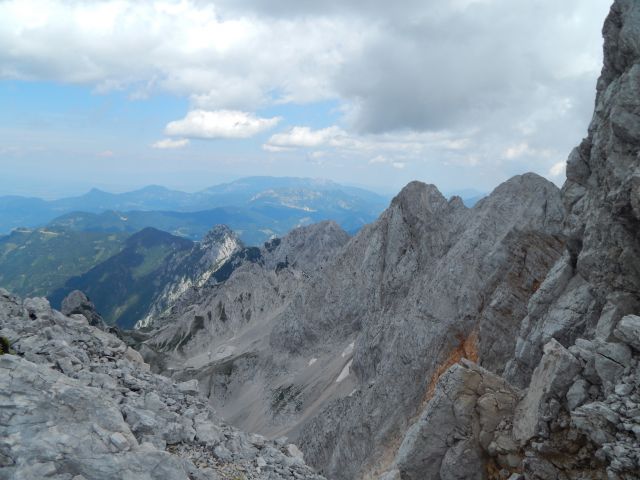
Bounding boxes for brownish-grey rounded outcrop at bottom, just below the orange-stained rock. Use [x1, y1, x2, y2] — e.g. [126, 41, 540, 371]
[394, 361, 518, 479]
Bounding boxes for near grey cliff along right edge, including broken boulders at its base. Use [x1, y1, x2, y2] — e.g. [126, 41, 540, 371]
[387, 0, 640, 479]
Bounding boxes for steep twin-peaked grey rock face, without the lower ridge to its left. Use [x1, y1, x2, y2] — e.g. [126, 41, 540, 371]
[288, 174, 563, 479]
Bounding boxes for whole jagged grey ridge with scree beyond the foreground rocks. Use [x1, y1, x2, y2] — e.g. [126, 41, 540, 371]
[142, 174, 563, 478]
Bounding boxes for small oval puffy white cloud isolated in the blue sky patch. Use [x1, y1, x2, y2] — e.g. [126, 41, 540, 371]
[165, 110, 280, 139]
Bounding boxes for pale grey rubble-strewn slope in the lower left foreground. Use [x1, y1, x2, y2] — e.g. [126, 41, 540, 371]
[0, 290, 321, 480]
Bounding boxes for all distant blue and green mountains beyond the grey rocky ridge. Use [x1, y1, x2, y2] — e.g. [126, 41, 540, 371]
[0, 177, 478, 316]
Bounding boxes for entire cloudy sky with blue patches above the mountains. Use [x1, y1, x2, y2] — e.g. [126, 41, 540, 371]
[0, 0, 611, 196]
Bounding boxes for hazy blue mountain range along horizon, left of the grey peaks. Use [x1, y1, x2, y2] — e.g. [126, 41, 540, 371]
[0, 177, 388, 239]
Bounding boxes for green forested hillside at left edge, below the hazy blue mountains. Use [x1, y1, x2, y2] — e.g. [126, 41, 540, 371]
[0, 227, 128, 297]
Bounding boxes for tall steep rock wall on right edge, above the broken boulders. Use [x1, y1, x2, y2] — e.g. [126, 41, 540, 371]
[507, 1, 640, 385]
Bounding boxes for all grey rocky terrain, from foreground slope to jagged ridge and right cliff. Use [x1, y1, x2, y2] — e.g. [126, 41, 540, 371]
[0, 0, 640, 480]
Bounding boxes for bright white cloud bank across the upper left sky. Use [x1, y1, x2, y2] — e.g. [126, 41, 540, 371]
[0, 0, 364, 110]
